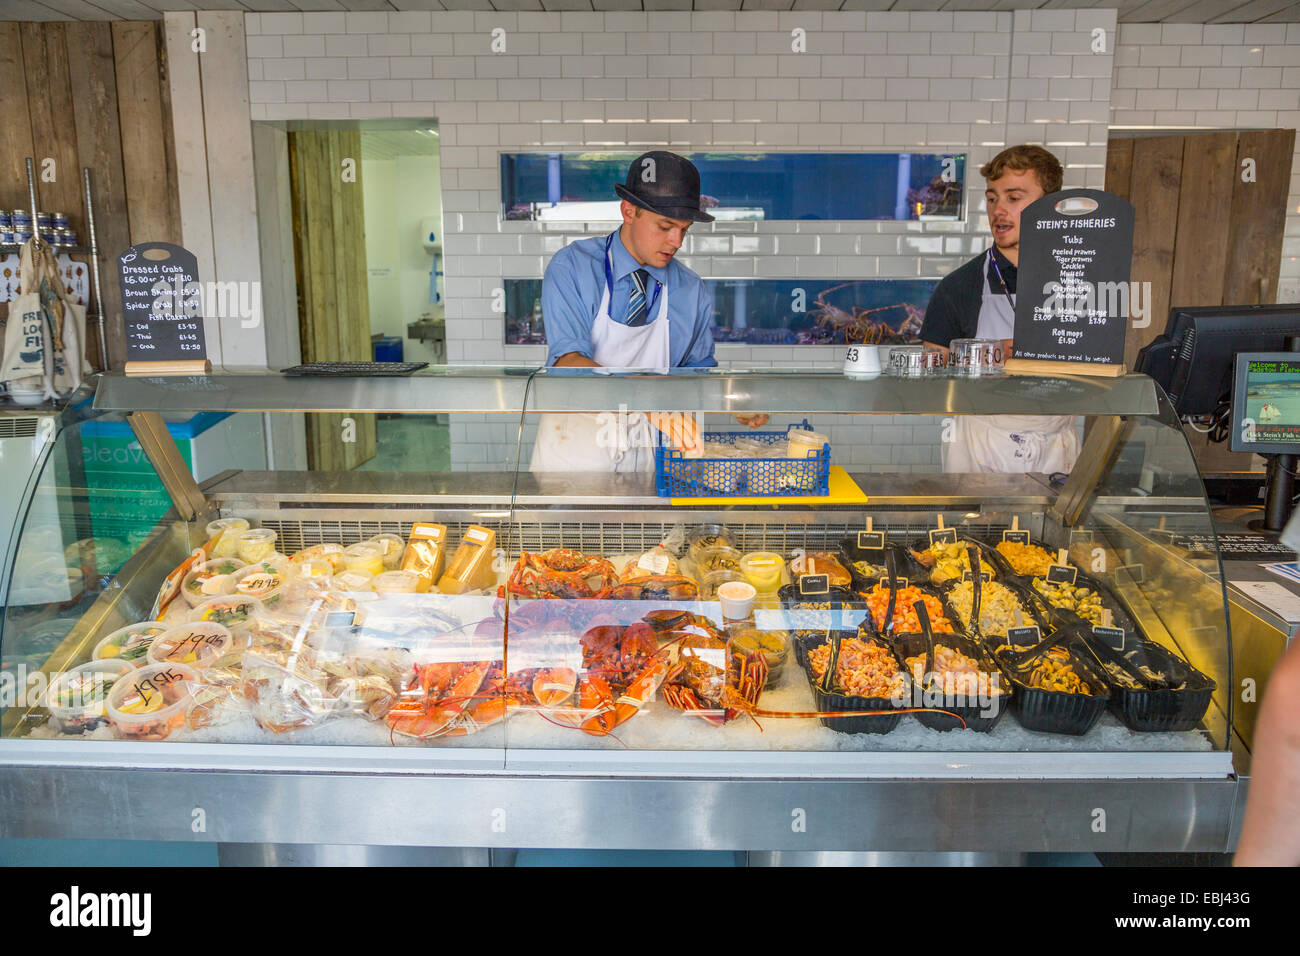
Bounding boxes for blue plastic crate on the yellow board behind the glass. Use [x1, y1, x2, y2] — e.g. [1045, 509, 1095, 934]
[655, 419, 831, 498]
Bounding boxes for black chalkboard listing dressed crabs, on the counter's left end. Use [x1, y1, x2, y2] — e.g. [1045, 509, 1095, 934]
[117, 242, 208, 362]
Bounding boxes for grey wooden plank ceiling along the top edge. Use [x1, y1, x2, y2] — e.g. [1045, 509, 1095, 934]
[0, 0, 1300, 23]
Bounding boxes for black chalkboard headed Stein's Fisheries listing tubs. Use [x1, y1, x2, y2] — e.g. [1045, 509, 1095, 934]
[1013, 189, 1134, 365]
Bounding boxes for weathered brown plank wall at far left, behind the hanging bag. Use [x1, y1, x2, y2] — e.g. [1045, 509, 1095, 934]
[0, 21, 181, 368]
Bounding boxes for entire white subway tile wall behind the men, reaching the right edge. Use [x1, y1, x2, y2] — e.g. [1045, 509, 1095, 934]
[246, 9, 1300, 471]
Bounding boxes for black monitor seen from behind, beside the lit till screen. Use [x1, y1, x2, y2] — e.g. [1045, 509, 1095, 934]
[1136, 303, 1300, 418]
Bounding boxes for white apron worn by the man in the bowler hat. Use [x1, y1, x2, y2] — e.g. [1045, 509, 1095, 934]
[528, 233, 672, 472]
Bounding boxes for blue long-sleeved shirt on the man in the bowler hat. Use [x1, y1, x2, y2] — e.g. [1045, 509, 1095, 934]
[542, 235, 718, 368]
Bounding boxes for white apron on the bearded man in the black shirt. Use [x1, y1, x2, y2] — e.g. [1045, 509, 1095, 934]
[943, 250, 1079, 475]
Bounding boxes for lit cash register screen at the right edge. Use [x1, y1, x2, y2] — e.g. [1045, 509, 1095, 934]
[1229, 352, 1300, 455]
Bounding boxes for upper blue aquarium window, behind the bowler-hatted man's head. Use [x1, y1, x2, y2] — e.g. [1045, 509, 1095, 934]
[501, 152, 966, 222]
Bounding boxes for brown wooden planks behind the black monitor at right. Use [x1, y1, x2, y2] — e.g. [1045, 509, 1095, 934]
[1106, 130, 1295, 472]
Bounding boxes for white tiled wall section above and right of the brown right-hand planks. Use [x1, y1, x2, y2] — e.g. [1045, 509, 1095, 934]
[1110, 23, 1300, 302]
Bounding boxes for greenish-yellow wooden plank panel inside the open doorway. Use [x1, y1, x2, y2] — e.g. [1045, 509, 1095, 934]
[289, 130, 376, 471]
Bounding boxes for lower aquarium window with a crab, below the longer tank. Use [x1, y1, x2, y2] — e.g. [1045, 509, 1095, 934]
[504, 278, 939, 346]
